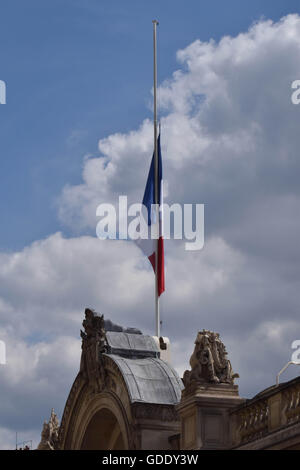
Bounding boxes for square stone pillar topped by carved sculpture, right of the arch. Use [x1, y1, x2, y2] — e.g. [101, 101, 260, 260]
[176, 330, 244, 450]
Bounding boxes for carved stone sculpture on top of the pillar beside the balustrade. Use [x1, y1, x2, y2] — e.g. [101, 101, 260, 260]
[183, 330, 239, 386]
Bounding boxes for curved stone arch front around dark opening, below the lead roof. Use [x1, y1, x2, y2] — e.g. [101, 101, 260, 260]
[59, 357, 132, 450]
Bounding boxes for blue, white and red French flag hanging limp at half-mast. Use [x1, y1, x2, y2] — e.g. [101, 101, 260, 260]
[138, 135, 165, 296]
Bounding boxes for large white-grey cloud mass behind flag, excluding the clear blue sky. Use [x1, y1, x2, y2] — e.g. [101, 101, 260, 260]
[0, 15, 300, 445]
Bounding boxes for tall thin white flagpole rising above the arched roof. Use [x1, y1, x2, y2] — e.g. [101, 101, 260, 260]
[152, 20, 160, 338]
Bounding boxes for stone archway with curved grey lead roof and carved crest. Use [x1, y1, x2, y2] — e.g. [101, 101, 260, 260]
[55, 309, 182, 450]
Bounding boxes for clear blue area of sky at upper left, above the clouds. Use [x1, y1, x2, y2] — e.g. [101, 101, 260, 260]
[0, 0, 299, 251]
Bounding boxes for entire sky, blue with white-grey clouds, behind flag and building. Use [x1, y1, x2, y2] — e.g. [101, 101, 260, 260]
[0, 0, 300, 448]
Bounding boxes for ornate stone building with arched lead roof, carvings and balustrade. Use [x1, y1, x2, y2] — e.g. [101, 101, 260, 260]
[38, 309, 300, 450]
